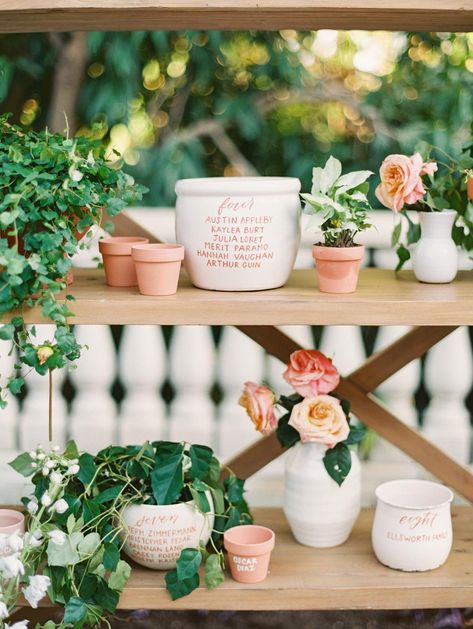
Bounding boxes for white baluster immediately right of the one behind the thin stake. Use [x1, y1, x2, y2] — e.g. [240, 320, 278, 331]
[70, 325, 117, 452]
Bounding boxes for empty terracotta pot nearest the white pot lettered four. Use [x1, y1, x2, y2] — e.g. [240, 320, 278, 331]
[131, 243, 184, 295]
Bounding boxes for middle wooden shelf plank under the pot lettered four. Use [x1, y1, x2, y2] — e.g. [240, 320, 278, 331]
[20, 269, 473, 326]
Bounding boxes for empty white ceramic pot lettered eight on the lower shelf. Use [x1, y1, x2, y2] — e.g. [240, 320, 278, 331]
[371, 479, 453, 572]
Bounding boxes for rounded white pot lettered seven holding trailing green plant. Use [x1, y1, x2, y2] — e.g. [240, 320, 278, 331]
[121, 493, 214, 570]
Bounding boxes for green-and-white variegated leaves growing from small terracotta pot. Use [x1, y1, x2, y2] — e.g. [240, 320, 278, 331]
[301, 156, 373, 247]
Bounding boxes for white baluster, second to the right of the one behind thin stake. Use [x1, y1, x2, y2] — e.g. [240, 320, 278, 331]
[119, 325, 167, 444]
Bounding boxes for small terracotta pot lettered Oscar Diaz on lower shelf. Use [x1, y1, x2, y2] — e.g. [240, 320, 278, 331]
[223, 524, 276, 583]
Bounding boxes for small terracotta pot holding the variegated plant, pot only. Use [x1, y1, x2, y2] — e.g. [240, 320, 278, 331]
[312, 245, 365, 293]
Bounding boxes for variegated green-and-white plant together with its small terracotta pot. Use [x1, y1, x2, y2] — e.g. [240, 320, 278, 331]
[301, 156, 373, 293]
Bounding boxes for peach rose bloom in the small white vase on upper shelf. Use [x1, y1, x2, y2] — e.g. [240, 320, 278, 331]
[375, 153, 437, 212]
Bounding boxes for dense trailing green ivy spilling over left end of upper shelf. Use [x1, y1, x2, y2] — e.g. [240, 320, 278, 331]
[0, 115, 146, 430]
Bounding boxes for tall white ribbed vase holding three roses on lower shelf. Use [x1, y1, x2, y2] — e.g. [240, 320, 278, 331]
[283, 442, 361, 548]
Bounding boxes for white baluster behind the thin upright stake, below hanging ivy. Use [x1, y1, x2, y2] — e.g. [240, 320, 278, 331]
[20, 325, 67, 450]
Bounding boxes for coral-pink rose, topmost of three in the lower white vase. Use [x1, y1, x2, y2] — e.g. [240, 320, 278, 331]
[283, 349, 340, 397]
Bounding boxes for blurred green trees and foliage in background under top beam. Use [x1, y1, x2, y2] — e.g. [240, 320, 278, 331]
[0, 30, 473, 205]
